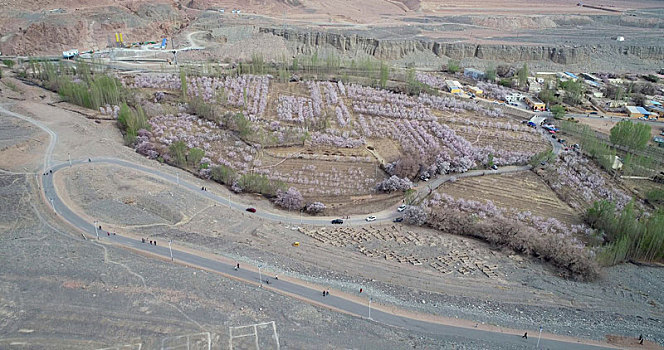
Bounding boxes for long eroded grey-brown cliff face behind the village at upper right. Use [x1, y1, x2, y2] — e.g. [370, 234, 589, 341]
[260, 27, 664, 65]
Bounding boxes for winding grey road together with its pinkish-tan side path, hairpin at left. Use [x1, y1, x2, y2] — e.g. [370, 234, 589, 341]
[0, 106, 615, 350]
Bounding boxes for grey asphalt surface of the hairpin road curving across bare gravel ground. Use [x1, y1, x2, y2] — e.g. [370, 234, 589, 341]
[0, 106, 607, 350]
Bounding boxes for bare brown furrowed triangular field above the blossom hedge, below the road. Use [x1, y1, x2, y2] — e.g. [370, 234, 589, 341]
[438, 171, 581, 224]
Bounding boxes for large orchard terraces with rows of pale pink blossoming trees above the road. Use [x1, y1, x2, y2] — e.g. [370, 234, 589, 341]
[128, 74, 548, 212]
